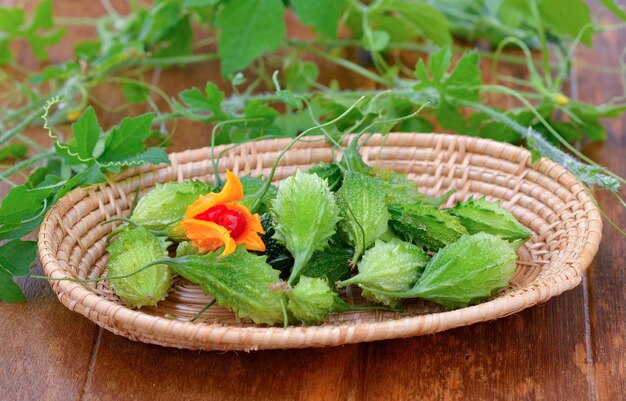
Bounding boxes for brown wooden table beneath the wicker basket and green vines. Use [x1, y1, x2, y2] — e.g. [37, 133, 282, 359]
[0, 0, 626, 401]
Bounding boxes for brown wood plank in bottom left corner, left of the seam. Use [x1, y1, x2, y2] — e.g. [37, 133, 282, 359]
[0, 260, 99, 401]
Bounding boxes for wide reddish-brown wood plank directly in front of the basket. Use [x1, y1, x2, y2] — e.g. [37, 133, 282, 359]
[78, 288, 589, 400]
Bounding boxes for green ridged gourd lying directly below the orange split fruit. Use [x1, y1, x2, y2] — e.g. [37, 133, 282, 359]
[172, 246, 283, 325]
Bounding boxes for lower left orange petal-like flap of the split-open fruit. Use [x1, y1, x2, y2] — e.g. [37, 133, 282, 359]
[182, 218, 237, 255]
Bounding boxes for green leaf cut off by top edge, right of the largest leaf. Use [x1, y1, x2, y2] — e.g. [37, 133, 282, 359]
[291, 0, 345, 39]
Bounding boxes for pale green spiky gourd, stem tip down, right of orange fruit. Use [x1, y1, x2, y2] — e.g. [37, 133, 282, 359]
[272, 170, 339, 282]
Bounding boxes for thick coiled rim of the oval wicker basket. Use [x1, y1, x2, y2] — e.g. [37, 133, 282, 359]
[38, 134, 602, 350]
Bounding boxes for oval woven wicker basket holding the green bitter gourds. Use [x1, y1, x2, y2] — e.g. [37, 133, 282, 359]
[39, 134, 602, 350]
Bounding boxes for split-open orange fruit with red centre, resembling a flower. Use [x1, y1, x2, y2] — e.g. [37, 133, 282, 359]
[182, 170, 265, 255]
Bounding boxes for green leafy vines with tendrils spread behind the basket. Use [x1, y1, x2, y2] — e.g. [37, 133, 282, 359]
[0, 0, 626, 301]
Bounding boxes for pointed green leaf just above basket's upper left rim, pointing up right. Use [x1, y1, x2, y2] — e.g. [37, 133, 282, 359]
[98, 113, 154, 164]
